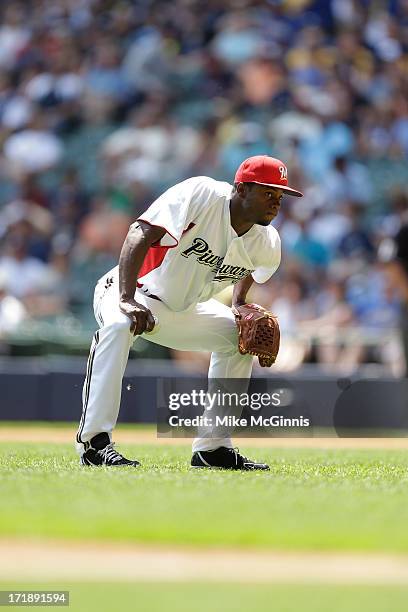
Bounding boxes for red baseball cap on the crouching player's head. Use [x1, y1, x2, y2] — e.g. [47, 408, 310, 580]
[234, 155, 303, 198]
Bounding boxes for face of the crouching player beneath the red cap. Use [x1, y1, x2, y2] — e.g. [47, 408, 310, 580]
[243, 183, 283, 225]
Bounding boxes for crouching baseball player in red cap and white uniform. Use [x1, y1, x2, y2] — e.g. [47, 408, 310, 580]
[76, 155, 302, 470]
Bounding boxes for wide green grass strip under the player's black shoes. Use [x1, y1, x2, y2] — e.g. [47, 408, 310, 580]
[0, 443, 408, 553]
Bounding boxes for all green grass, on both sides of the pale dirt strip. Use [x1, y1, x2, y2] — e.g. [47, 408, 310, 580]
[0, 428, 408, 612]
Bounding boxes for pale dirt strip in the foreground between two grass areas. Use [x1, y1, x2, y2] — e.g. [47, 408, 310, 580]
[0, 539, 408, 585]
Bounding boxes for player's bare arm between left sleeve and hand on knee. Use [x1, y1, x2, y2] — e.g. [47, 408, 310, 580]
[119, 222, 165, 299]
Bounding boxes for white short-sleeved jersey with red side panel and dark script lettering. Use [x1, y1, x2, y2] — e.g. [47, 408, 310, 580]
[107, 176, 281, 311]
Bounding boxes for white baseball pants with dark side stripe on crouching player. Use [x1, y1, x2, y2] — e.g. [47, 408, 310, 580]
[77, 274, 253, 454]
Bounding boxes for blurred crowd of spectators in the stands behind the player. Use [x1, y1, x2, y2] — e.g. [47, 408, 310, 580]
[0, 0, 408, 372]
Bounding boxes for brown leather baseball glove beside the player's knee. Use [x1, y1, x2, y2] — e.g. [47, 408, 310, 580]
[232, 304, 280, 368]
